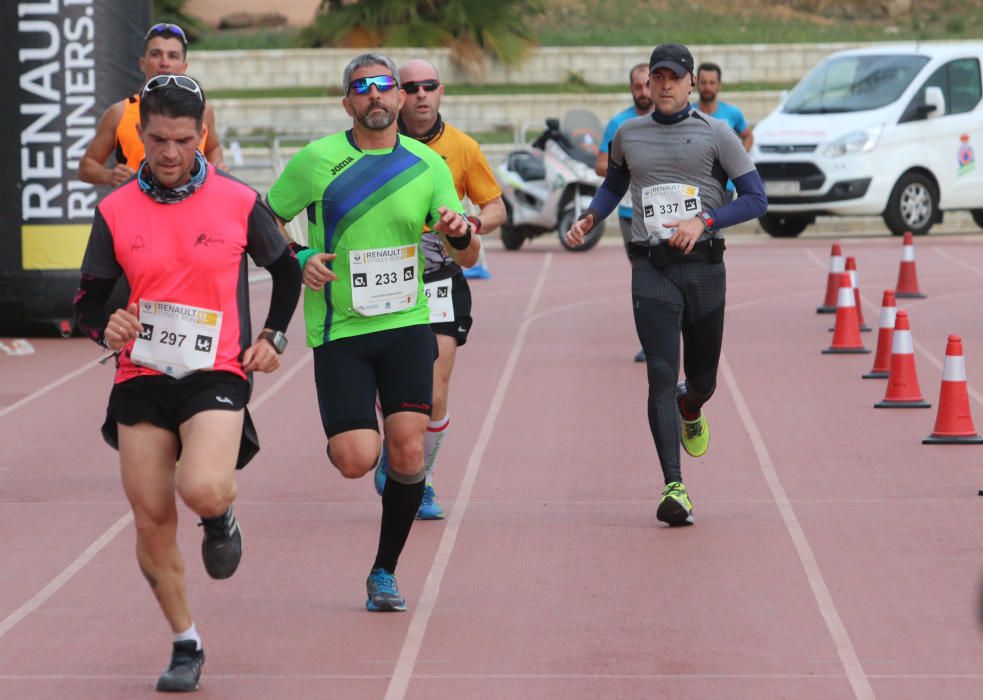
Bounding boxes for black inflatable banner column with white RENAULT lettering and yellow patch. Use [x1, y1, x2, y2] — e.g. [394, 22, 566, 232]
[0, 0, 151, 322]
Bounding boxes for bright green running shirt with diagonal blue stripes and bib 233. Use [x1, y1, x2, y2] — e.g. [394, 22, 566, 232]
[267, 131, 464, 347]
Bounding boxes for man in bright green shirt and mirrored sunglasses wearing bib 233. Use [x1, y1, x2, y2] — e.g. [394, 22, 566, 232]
[267, 54, 473, 611]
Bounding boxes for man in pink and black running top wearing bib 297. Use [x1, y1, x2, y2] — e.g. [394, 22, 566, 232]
[75, 75, 300, 691]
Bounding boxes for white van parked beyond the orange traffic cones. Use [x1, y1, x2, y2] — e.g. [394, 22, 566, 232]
[751, 43, 983, 237]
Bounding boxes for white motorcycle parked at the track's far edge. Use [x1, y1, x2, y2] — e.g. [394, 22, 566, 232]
[495, 111, 604, 252]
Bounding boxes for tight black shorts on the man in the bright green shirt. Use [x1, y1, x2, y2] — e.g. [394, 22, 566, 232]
[314, 325, 437, 438]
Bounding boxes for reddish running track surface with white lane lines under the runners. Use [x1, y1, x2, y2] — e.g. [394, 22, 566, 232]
[0, 232, 983, 699]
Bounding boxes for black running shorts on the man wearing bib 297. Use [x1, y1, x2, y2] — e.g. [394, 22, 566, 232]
[102, 372, 259, 469]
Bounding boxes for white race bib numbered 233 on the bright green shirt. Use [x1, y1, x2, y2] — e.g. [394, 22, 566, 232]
[348, 244, 418, 316]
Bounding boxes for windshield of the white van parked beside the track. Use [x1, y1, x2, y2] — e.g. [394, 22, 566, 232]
[782, 55, 929, 114]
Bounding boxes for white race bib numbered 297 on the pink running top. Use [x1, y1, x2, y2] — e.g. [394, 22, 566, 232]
[130, 299, 222, 379]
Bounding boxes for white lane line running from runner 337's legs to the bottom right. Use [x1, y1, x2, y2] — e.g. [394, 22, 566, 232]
[720, 354, 874, 700]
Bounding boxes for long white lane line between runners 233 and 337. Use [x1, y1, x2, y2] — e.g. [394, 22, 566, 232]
[385, 253, 553, 700]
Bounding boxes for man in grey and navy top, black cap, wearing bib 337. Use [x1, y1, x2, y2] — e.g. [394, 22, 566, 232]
[566, 44, 767, 525]
